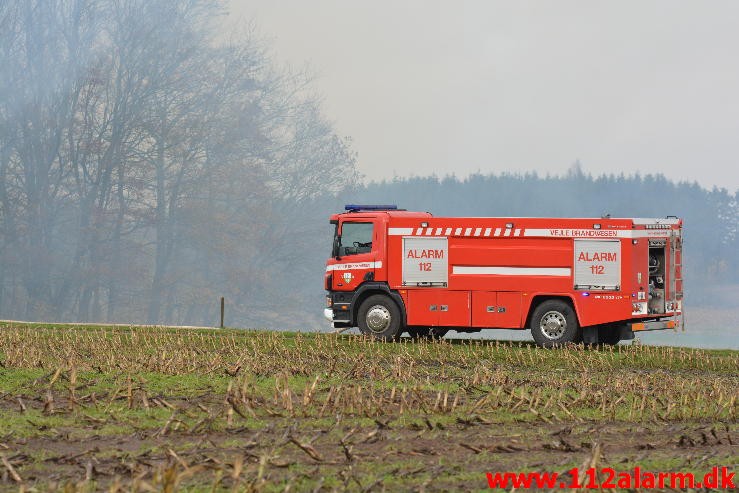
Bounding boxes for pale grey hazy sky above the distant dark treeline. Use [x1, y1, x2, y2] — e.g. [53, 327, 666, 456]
[231, 0, 739, 191]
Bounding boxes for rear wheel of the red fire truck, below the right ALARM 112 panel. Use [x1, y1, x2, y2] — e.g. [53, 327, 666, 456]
[529, 300, 582, 348]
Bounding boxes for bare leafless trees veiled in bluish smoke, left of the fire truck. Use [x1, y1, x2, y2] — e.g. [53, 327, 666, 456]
[0, 0, 355, 322]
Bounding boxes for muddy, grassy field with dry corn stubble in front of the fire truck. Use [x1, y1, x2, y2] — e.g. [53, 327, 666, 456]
[0, 324, 739, 491]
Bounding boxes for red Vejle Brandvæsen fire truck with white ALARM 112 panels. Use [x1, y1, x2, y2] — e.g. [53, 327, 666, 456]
[325, 205, 683, 347]
